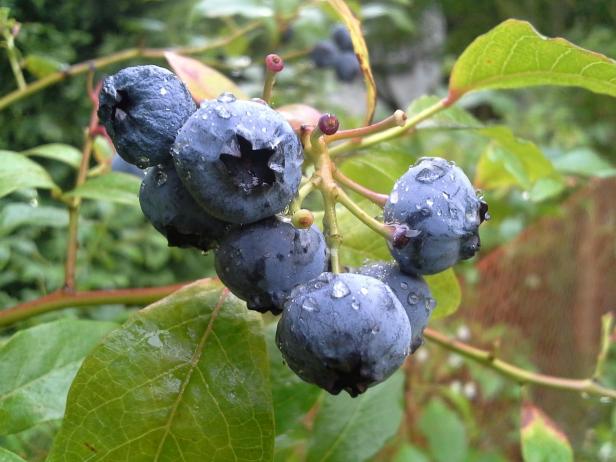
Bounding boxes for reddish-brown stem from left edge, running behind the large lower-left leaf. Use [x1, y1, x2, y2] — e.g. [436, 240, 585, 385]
[0, 282, 189, 327]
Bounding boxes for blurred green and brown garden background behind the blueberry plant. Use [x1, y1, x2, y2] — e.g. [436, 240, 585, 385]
[0, 0, 616, 462]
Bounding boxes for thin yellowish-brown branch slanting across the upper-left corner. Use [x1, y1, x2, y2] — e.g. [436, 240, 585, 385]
[0, 21, 261, 111]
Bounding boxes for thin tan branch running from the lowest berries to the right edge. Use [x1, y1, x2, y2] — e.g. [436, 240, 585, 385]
[424, 328, 616, 399]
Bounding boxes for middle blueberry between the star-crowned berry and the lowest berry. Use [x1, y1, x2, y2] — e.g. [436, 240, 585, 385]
[215, 217, 328, 314]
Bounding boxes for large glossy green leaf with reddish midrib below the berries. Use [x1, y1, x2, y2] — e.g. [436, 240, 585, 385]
[48, 280, 274, 462]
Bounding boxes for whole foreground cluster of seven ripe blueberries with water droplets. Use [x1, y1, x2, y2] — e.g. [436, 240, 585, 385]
[99, 64, 487, 396]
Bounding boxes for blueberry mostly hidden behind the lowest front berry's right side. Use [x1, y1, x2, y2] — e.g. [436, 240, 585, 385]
[356, 262, 436, 354]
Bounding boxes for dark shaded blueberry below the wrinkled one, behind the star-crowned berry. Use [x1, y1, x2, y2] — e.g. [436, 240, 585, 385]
[139, 162, 229, 251]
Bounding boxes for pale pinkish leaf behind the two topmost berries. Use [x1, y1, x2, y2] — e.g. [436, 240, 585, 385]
[165, 51, 248, 102]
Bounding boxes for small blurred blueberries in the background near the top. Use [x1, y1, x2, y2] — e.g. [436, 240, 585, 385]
[310, 24, 361, 82]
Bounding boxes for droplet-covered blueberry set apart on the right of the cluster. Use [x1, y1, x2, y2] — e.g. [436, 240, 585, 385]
[383, 157, 482, 274]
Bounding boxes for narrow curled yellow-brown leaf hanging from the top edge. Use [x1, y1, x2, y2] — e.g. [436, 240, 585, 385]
[328, 0, 376, 125]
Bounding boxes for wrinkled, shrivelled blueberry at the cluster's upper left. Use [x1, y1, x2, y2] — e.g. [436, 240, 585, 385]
[98, 66, 197, 168]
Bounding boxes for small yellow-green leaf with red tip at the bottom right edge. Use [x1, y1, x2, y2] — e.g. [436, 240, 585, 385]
[520, 404, 573, 462]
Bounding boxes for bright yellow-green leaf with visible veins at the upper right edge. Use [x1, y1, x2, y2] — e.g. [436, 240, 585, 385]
[449, 19, 616, 101]
